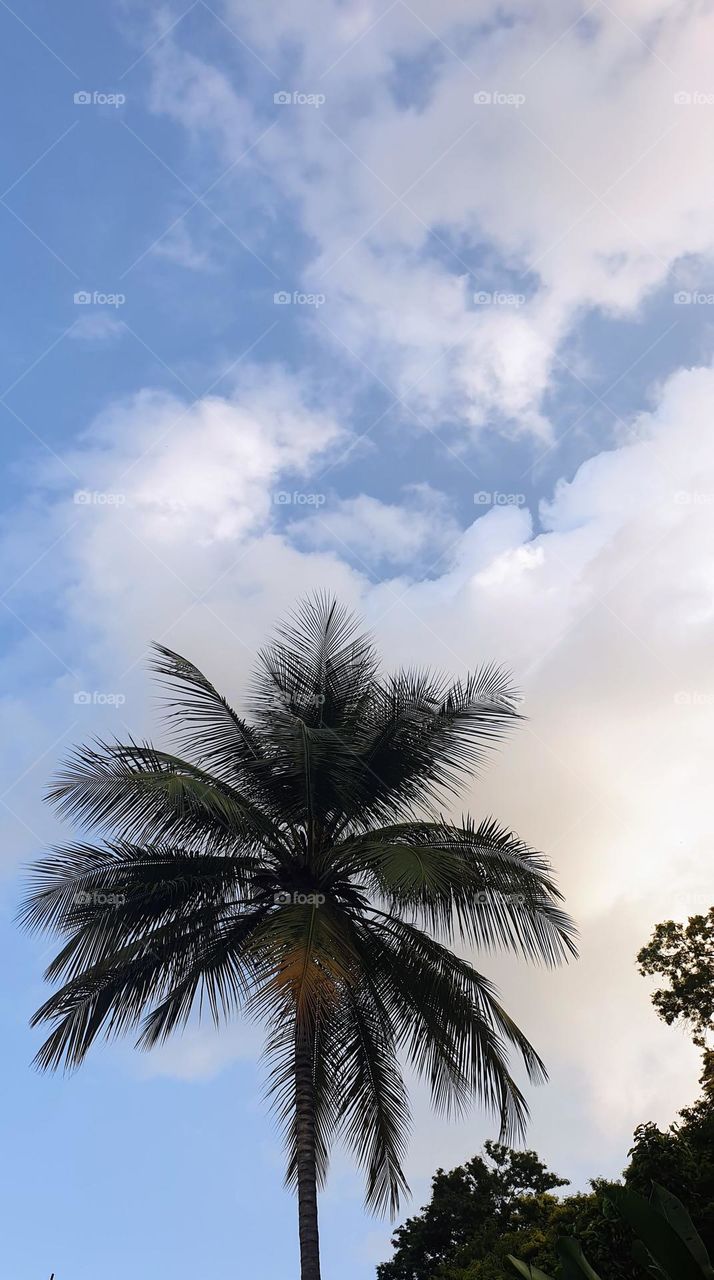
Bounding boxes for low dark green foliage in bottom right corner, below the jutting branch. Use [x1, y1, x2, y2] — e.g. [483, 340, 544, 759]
[377, 1097, 714, 1280]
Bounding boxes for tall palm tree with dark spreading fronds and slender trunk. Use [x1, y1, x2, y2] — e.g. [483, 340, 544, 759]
[22, 596, 575, 1280]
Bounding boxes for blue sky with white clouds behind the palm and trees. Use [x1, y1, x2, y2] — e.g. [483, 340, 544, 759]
[0, 0, 714, 1280]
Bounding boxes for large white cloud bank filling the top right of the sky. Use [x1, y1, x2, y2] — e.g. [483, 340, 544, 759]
[142, 0, 714, 435]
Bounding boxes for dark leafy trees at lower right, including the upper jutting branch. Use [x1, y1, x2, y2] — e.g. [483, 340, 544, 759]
[377, 909, 714, 1280]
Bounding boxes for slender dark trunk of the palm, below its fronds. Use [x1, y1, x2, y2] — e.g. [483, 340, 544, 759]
[296, 1029, 320, 1280]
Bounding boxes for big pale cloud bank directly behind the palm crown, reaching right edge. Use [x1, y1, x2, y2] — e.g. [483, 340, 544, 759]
[6, 355, 714, 1164]
